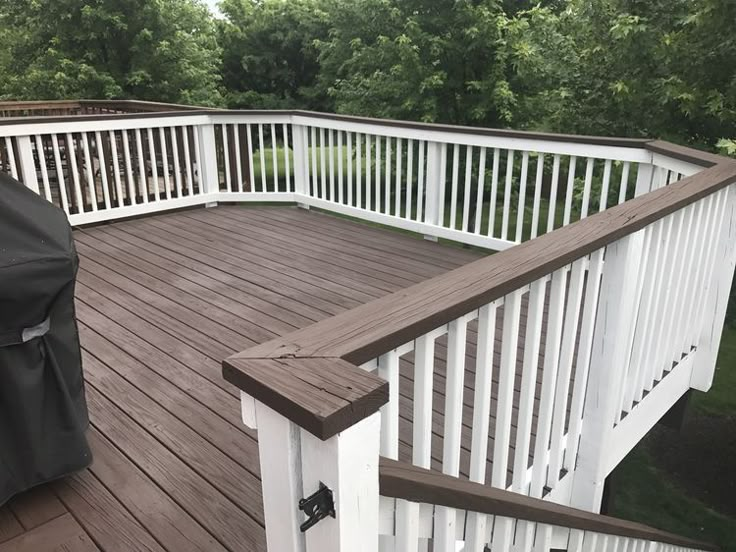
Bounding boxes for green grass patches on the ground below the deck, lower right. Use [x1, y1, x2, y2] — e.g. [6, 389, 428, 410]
[612, 328, 736, 552]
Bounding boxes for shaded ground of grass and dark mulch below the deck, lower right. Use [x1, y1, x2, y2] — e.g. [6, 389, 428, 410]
[611, 328, 736, 552]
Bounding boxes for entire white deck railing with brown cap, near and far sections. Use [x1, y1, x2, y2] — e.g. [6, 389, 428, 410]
[0, 105, 736, 551]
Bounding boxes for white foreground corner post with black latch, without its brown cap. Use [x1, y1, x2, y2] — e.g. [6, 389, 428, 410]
[241, 393, 381, 552]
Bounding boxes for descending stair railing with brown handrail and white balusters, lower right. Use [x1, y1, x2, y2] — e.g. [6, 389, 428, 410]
[379, 458, 718, 552]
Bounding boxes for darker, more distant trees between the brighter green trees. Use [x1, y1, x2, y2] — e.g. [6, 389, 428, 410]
[218, 0, 331, 111]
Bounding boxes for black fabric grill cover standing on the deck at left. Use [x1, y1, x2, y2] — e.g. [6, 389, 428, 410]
[0, 174, 92, 505]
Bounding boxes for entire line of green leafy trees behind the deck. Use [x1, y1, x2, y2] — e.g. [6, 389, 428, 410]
[0, 0, 736, 324]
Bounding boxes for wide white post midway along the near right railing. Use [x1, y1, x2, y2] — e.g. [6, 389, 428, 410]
[571, 234, 643, 513]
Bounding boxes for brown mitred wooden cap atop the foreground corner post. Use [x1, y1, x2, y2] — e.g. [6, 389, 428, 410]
[223, 358, 388, 440]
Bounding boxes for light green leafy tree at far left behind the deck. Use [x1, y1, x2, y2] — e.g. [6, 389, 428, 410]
[0, 0, 222, 105]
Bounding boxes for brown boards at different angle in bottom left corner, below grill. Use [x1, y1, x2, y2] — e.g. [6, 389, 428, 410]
[0, 514, 99, 552]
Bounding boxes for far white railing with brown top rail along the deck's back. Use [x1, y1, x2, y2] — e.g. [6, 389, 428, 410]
[0, 111, 702, 244]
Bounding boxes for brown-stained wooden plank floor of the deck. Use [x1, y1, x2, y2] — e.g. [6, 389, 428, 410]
[0, 207, 479, 552]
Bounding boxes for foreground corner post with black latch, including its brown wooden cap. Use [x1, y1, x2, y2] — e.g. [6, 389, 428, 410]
[223, 355, 388, 552]
